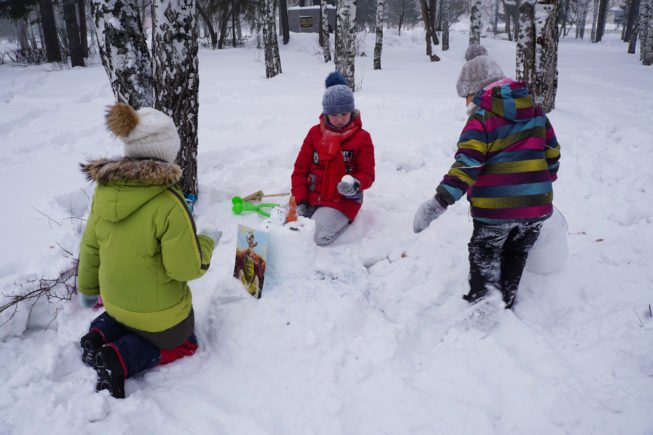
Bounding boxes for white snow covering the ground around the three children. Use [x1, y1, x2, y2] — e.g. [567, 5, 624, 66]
[0, 30, 653, 435]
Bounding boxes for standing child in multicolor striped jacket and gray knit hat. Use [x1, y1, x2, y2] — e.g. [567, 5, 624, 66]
[413, 45, 560, 308]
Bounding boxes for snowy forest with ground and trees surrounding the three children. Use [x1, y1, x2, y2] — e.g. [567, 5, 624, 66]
[0, 0, 653, 435]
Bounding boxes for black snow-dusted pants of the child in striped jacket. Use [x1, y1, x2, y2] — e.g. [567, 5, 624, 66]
[463, 220, 542, 308]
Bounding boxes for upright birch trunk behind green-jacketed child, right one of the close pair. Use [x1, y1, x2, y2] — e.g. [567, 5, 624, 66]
[152, 0, 199, 195]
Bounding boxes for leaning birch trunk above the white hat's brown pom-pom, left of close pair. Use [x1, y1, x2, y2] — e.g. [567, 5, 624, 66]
[91, 0, 154, 109]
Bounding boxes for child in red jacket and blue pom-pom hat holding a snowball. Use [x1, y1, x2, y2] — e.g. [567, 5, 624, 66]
[291, 71, 374, 246]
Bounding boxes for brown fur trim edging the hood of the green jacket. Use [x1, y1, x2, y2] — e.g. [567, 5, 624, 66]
[80, 158, 181, 186]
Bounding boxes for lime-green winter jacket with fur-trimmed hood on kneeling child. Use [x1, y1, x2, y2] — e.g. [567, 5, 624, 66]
[77, 159, 213, 332]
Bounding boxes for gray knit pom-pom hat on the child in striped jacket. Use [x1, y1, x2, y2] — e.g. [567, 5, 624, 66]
[456, 44, 506, 98]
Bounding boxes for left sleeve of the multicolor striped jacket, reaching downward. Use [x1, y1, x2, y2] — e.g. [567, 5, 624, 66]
[436, 116, 488, 205]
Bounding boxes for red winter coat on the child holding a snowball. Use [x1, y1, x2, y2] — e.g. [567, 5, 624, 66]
[291, 112, 374, 221]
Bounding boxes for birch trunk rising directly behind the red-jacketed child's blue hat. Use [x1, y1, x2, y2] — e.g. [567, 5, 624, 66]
[335, 0, 356, 91]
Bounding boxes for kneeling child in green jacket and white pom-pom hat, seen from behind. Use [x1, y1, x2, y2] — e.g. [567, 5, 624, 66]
[77, 103, 219, 398]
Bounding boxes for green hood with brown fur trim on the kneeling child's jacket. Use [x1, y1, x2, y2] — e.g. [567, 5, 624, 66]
[81, 158, 181, 222]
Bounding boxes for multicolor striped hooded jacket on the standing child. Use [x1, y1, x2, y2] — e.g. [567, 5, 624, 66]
[437, 79, 560, 223]
